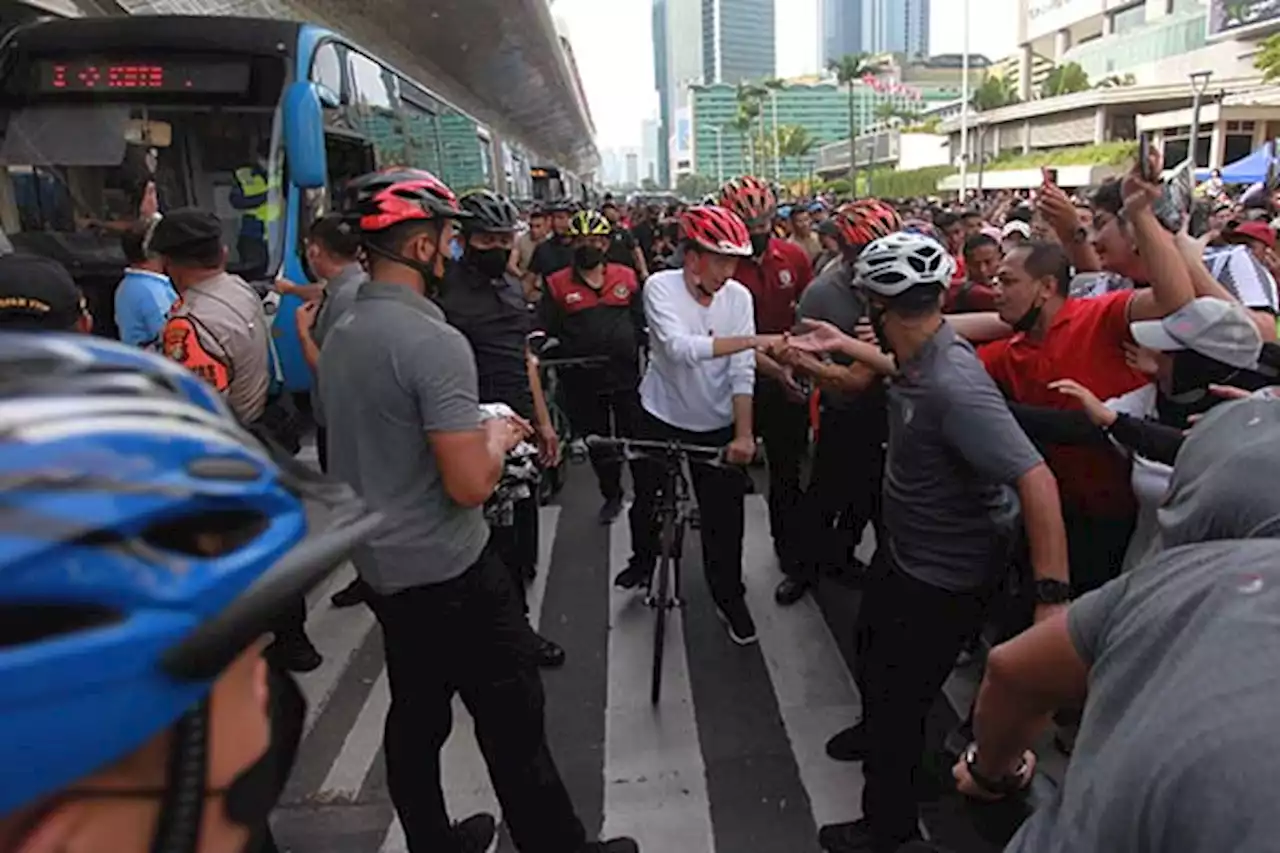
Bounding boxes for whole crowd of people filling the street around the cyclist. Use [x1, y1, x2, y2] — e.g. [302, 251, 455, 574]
[0, 146, 1280, 853]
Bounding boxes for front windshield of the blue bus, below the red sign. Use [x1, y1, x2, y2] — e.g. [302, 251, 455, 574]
[0, 101, 284, 278]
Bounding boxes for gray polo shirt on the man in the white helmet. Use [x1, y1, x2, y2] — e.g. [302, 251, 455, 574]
[883, 321, 1042, 592]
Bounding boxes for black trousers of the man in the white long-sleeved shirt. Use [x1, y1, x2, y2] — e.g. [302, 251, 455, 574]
[630, 410, 746, 605]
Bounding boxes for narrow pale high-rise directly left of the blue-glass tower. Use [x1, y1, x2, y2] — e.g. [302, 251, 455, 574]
[653, 0, 703, 187]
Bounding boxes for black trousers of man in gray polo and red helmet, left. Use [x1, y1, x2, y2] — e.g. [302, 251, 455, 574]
[371, 548, 586, 853]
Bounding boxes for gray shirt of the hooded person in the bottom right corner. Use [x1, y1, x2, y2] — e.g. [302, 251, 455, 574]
[1005, 539, 1280, 853]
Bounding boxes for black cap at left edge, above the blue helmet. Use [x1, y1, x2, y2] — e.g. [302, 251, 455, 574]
[0, 255, 84, 332]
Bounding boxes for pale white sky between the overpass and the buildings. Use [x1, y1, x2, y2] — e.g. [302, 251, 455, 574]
[552, 0, 1018, 149]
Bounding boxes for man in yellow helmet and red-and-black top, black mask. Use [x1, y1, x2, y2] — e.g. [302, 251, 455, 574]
[541, 210, 645, 524]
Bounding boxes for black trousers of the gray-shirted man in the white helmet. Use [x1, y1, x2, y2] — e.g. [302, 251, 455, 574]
[855, 548, 987, 853]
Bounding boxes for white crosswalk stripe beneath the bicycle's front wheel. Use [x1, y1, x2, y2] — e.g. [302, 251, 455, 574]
[602, 523, 716, 853]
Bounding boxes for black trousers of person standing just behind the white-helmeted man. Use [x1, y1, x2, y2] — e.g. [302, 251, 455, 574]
[782, 409, 884, 581]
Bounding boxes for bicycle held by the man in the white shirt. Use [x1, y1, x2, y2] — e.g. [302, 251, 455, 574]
[586, 435, 737, 706]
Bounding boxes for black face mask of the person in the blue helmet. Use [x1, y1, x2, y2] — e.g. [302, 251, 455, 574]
[223, 667, 307, 835]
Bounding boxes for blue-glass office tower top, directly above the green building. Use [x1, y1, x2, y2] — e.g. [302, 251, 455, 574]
[701, 0, 777, 85]
